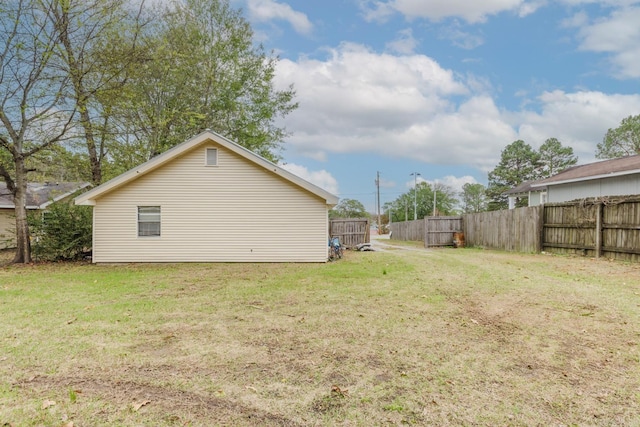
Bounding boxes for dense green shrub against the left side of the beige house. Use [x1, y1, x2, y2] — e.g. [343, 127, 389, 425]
[29, 202, 93, 261]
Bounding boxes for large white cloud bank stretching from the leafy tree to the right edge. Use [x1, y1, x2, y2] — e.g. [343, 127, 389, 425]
[276, 44, 640, 176]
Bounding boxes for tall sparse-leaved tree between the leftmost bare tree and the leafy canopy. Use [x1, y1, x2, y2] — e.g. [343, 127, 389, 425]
[47, 0, 145, 185]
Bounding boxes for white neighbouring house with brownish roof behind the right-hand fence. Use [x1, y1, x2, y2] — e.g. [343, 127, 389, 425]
[531, 155, 640, 203]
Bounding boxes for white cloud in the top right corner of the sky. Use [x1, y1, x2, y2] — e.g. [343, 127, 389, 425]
[567, 7, 640, 78]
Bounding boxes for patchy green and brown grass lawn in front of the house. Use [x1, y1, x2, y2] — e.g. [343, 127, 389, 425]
[0, 249, 640, 427]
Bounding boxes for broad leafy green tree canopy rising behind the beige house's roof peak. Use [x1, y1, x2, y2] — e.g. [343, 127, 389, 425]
[113, 0, 297, 176]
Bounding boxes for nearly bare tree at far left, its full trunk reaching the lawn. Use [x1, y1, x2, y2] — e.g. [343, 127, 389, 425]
[0, 0, 74, 263]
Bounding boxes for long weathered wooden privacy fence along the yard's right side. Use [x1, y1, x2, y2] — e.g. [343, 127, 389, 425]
[390, 197, 640, 262]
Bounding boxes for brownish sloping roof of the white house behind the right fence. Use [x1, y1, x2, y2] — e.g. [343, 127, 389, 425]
[532, 155, 640, 187]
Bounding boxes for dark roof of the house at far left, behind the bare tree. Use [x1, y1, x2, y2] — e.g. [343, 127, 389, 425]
[0, 182, 91, 209]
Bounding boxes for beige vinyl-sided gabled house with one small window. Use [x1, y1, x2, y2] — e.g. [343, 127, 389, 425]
[75, 131, 338, 262]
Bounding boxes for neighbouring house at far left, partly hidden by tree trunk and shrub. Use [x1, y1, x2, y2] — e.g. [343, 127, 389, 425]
[0, 181, 90, 249]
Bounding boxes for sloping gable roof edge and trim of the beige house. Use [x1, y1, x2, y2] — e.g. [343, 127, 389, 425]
[75, 130, 338, 207]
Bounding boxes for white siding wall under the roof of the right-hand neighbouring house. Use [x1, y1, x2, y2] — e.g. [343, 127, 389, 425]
[548, 175, 640, 203]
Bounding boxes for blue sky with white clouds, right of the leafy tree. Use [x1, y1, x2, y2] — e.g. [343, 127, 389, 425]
[231, 0, 640, 210]
